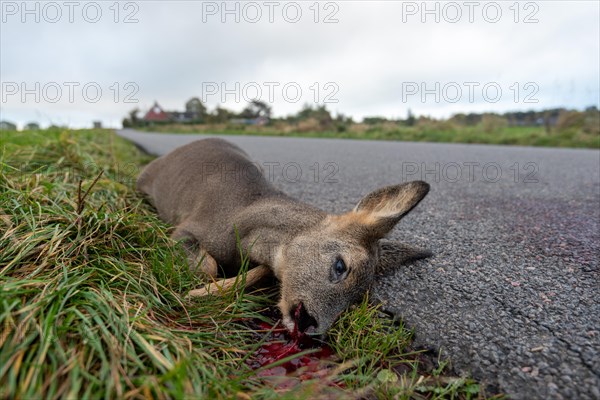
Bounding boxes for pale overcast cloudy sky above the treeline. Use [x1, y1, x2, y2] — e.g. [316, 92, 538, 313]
[0, 0, 600, 127]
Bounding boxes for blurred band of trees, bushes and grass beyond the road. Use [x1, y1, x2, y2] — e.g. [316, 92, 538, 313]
[123, 98, 600, 149]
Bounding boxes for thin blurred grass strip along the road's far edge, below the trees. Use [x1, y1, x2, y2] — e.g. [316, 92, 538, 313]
[140, 121, 600, 149]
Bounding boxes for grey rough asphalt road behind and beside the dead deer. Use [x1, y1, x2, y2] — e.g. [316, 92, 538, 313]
[119, 130, 600, 399]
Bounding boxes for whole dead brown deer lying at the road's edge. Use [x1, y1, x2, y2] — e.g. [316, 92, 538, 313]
[138, 139, 429, 332]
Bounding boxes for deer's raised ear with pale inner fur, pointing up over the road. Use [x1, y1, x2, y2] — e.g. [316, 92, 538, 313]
[354, 181, 429, 239]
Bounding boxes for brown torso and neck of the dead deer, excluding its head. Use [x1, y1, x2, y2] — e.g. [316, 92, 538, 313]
[138, 139, 325, 277]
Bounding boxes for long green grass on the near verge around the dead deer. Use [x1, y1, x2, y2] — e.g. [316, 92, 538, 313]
[0, 130, 502, 399]
